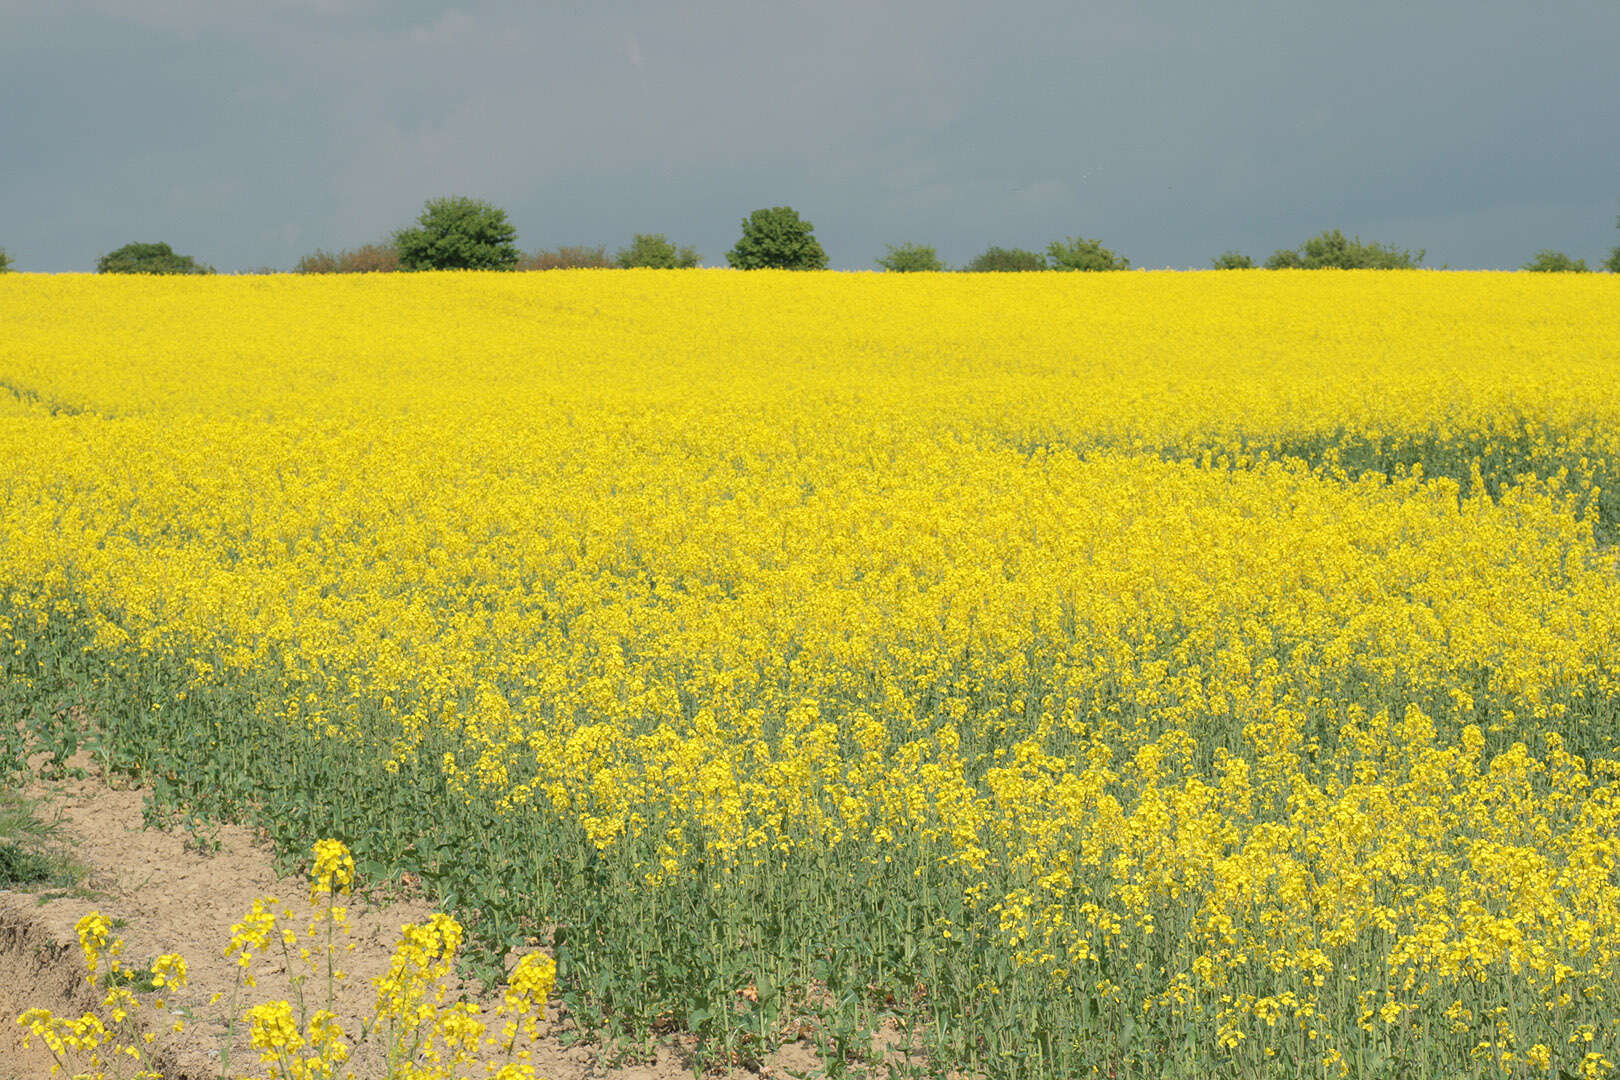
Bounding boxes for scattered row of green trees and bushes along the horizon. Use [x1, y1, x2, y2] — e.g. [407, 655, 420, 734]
[0, 196, 1620, 274]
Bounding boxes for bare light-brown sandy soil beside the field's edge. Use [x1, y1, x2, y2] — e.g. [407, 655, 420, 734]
[0, 759, 823, 1080]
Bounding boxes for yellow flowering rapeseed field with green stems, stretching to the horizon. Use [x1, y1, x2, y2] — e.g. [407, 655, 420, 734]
[0, 270, 1620, 1077]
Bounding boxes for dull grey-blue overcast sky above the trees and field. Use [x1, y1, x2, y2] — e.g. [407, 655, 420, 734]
[9, 0, 1620, 270]
